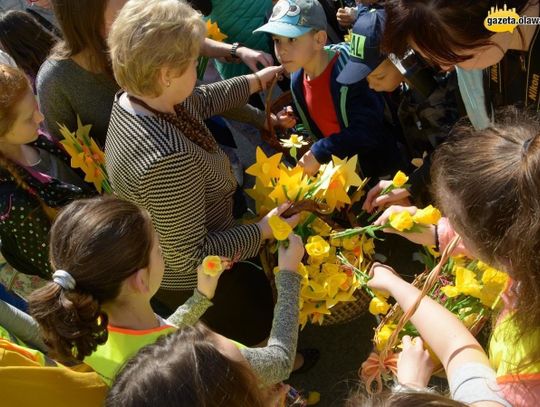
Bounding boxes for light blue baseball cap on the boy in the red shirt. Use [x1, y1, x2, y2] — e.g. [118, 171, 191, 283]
[253, 0, 326, 38]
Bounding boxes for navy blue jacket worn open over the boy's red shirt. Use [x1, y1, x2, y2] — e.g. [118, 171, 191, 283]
[291, 43, 401, 177]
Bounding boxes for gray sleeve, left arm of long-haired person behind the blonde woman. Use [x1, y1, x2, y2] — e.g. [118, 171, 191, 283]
[36, 60, 77, 140]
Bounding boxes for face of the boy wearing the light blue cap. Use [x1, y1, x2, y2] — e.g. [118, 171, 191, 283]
[272, 32, 324, 72]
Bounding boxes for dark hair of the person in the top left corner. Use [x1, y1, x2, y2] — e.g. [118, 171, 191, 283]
[0, 10, 57, 78]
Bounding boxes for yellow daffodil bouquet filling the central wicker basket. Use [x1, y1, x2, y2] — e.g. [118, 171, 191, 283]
[246, 143, 382, 327]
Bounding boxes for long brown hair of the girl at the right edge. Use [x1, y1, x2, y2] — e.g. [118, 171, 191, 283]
[432, 107, 540, 360]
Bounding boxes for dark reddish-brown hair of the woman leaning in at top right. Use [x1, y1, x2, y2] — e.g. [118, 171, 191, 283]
[381, 0, 533, 65]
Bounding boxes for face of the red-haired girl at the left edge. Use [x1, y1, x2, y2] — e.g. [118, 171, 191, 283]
[0, 89, 44, 145]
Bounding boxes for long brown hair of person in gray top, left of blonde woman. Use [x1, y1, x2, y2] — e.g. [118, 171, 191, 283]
[51, 0, 112, 76]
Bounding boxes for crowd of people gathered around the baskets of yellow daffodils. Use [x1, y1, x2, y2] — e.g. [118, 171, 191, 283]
[0, 0, 540, 407]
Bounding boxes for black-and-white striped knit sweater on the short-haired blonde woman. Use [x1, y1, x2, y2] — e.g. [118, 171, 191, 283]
[105, 77, 261, 290]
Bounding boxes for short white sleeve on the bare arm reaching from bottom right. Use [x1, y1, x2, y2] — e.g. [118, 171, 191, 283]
[448, 363, 512, 407]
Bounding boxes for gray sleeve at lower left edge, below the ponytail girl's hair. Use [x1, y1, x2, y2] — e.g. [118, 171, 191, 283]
[0, 300, 48, 352]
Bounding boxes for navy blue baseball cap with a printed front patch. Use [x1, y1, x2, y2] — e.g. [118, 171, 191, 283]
[337, 9, 386, 85]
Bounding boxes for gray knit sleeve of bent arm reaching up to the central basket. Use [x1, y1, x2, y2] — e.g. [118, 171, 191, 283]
[240, 270, 301, 386]
